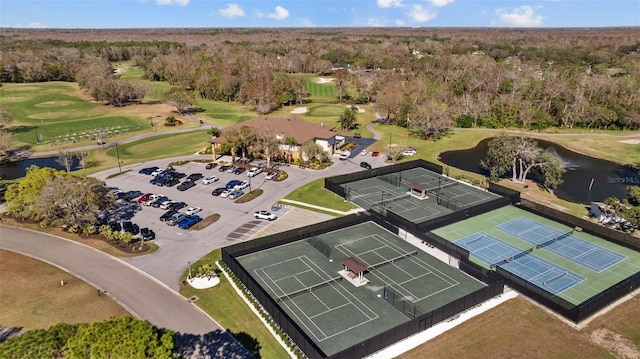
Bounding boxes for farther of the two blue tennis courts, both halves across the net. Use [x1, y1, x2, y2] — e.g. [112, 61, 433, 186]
[495, 217, 627, 272]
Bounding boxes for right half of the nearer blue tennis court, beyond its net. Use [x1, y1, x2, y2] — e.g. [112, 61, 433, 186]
[500, 255, 585, 295]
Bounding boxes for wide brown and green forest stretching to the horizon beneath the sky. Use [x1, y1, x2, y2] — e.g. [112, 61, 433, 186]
[0, 29, 640, 138]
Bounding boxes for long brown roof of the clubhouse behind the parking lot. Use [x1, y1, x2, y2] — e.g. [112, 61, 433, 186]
[211, 117, 336, 145]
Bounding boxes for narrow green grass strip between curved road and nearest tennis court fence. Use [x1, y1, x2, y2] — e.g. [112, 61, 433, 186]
[180, 249, 288, 359]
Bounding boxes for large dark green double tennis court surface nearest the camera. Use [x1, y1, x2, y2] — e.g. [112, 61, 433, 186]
[237, 222, 485, 355]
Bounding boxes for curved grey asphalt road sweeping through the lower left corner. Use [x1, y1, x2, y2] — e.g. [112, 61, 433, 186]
[0, 226, 251, 358]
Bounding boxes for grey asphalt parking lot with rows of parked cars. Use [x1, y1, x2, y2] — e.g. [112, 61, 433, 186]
[94, 155, 384, 289]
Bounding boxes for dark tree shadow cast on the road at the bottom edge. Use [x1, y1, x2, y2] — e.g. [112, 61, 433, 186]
[175, 330, 260, 359]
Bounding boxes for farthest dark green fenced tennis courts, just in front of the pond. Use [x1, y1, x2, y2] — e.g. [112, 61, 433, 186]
[342, 167, 498, 223]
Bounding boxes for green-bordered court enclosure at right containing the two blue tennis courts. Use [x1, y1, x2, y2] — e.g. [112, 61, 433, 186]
[433, 206, 640, 305]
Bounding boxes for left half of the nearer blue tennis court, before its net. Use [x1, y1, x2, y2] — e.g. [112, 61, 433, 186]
[454, 232, 523, 266]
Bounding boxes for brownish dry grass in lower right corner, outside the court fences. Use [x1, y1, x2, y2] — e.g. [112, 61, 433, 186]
[399, 297, 628, 359]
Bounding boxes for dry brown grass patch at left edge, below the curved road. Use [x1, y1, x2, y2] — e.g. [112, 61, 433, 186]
[0, 250, 129, 331]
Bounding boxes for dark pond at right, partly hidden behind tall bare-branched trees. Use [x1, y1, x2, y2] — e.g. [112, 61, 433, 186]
[440, 138, 640, 204]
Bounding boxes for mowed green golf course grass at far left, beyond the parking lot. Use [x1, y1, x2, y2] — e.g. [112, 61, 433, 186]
[0, 82, 181, 151]
